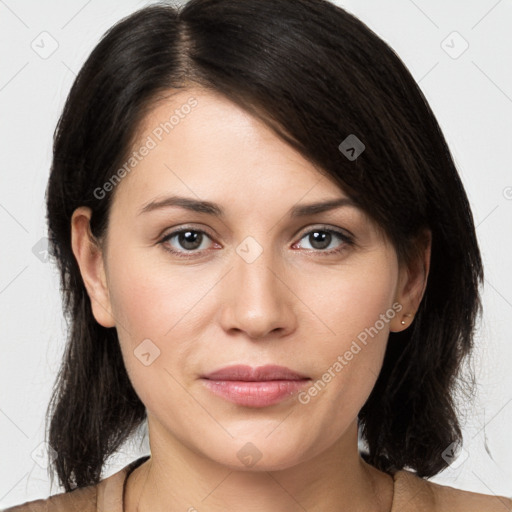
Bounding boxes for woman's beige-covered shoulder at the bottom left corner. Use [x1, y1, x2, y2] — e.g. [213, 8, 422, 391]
[0, 486, 96, 512]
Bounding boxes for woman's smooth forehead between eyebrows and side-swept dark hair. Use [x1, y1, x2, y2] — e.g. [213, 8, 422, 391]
[109, 88, 343, 214]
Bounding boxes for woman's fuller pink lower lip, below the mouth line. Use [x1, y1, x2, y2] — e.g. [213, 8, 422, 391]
[202, 379, 311, 407]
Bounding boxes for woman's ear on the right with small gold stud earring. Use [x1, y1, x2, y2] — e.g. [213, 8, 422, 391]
[390, 229, 432, 332]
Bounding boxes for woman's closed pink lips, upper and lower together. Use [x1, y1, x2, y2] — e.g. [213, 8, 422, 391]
[201, 365, 311, 407]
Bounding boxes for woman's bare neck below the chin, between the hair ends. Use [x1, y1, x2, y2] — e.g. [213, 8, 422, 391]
[124, 422, 393, 512]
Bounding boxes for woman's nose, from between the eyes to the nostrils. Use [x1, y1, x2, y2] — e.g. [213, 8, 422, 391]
[223, 236, 293, 338]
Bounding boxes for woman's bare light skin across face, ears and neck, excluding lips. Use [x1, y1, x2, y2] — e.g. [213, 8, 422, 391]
[71, 88, 430, 512]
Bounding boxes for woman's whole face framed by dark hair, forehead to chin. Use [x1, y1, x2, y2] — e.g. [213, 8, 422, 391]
[73, 89, 424, 469]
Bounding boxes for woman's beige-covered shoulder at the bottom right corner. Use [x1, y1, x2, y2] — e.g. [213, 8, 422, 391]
[392, 470, 512, 512]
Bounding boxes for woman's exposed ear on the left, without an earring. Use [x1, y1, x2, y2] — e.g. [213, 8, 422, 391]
[71, 206, 115, 327]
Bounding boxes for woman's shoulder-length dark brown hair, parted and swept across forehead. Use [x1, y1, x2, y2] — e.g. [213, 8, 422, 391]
[47, 0, 483, 491]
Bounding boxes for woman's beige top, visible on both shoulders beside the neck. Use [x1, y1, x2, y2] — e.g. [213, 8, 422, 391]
[4, 455, 512, 512]
